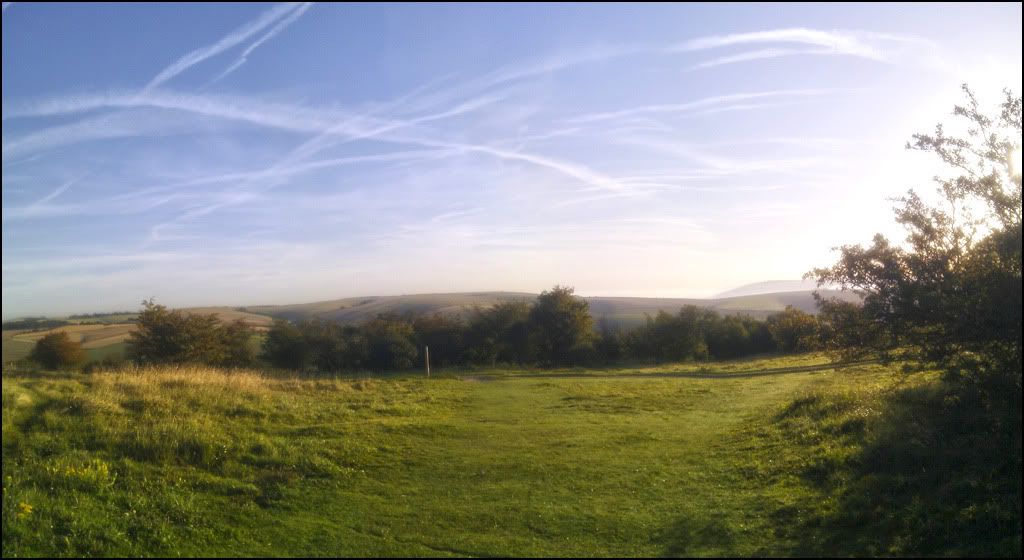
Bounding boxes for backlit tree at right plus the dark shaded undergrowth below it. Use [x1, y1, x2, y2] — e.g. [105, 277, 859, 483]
[801, 86, 1022, 556]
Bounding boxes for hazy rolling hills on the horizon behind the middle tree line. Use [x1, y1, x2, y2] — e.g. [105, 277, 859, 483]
[244, 290, 857, 326]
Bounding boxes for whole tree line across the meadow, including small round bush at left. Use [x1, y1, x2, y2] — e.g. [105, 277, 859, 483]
[39, 287, 826, 374]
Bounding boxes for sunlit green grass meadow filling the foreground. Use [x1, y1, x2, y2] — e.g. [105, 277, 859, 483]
[3, 355, 1020, 556]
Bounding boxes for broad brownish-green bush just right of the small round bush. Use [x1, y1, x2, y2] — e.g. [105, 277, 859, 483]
[128, 299, 255, 368]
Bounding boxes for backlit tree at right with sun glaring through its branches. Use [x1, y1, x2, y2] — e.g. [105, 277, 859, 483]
[810, 85, 1021, 391]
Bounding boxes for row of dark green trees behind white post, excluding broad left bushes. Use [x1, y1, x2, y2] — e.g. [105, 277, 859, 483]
[261, 286, 820, 374]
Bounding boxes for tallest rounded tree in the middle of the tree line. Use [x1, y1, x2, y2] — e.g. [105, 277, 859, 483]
[527, 286, 594, 365]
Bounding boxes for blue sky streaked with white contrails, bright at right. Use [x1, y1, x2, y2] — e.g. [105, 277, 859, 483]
[2, 2, 1022, 318]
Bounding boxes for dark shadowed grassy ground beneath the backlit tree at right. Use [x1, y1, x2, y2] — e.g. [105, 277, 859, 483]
[774, 377, 1021, 557]
